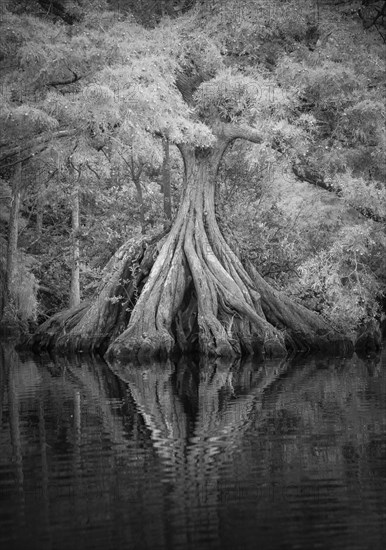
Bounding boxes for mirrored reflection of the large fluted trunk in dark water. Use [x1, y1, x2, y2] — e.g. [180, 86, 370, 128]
[105, 358, 288, 545]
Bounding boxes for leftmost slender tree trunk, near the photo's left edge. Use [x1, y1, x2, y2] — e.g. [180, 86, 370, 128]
[3, 154, 22, 316]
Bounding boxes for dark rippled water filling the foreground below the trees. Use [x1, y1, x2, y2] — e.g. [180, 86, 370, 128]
[0, 347, 386, 550]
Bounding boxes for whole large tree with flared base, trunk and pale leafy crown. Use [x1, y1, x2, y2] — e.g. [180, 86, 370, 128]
[32, 20, 347, 357]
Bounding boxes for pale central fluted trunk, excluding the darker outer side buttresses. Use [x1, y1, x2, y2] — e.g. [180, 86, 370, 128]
[108, 144, 285, 357]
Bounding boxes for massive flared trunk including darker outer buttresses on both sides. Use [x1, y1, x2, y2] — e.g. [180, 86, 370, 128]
[35, 140, 352, 360]
